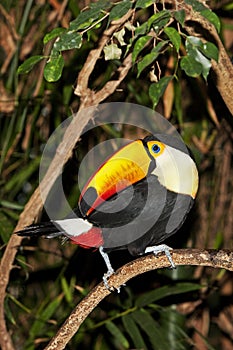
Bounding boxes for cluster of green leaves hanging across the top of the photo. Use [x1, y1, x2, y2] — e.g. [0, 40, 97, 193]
[18, 0, 220, 107]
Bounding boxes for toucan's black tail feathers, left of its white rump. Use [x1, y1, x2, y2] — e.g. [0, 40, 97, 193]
[15, 221, 64, 238]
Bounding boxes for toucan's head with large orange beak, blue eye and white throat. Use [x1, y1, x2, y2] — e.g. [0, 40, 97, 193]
[79, 134, 198, 217]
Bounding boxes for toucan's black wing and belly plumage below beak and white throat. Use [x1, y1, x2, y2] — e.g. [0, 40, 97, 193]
[85, 175, 193, 254]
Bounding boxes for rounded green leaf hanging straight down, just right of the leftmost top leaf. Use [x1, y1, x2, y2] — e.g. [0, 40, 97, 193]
[44, 55, 64, 82]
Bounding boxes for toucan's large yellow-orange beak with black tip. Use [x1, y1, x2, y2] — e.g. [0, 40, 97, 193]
[79, 140, 151, 217]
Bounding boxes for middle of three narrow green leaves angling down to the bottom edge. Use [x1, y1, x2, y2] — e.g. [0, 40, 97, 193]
[122, 315, 147, 350]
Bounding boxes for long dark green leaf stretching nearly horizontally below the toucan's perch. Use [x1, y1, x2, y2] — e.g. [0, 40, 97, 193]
[136, 282, 202, 307]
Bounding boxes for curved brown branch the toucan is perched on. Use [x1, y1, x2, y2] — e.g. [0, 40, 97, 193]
[45, 249, 233, 350]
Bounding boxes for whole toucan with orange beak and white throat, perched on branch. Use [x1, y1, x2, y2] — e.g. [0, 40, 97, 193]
[17, 133, 198, 287]
